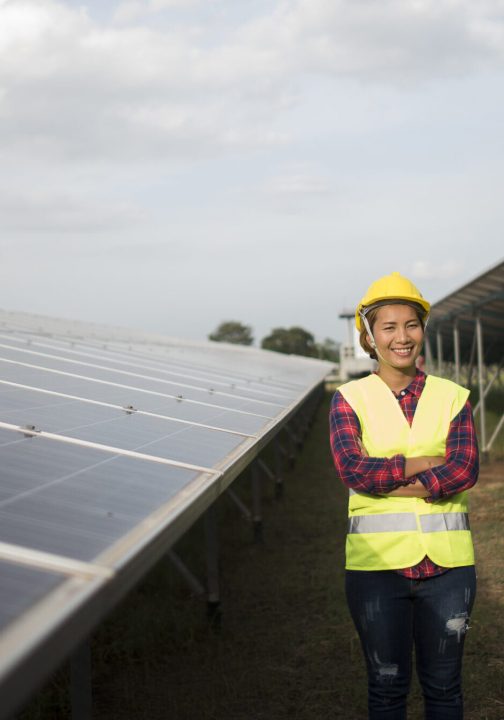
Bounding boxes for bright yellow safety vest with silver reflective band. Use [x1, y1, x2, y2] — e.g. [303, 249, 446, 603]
[338, 374, 474, 570]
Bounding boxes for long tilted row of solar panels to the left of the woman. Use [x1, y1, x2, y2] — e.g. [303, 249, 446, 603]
[0, 311, 332, 718]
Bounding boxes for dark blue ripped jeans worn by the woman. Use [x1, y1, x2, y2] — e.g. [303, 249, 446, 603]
[346, 565, 476, 720]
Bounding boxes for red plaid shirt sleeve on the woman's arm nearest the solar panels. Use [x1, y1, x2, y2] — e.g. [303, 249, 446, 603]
[329, 392, 415, 495]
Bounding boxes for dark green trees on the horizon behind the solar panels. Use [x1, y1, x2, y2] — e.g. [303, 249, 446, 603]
[208, 320, 339, 362]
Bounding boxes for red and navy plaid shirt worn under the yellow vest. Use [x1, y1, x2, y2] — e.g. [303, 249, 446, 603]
[329, 370, 479, 580]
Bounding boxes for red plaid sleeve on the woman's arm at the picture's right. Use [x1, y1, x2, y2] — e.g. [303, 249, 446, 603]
[415, 401, 479, 502]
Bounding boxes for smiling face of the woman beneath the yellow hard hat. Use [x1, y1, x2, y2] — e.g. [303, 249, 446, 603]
[368, 305, 424, 369]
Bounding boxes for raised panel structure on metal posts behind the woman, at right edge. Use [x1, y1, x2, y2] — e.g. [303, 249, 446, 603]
[426, 261, 504, 455]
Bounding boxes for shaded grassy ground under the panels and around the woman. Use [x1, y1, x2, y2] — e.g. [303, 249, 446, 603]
[20, 396, 504, 720]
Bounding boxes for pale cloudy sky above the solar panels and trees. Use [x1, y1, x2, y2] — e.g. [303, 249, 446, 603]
[0, 0, 504, 348]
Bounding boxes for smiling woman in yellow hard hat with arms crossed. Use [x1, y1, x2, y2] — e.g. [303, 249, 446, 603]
[330, 273, 479, 720]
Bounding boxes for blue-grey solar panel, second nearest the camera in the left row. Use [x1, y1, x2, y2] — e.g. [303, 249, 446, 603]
[0, 437, 203, 562]
